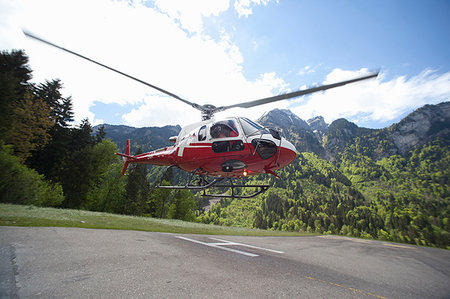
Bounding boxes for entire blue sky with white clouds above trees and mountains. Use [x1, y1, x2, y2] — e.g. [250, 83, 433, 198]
[0, 0, 450, 128]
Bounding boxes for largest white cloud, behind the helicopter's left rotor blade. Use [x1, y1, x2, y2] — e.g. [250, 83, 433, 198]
[0, 0, 286, 126]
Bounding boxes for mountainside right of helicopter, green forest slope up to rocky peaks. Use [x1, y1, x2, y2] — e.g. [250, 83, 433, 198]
[199, 106, 450, 248]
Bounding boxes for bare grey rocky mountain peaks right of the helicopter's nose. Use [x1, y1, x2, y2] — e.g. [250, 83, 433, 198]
[258, 102, 450, 161]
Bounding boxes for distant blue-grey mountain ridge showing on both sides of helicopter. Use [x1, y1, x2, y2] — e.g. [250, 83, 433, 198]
[94, 102, 450, 161]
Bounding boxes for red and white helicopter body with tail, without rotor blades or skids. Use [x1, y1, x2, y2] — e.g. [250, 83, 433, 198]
[119, 117, 297, 177]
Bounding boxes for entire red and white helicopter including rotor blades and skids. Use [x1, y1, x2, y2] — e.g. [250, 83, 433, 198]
[24, 32, 378, 198]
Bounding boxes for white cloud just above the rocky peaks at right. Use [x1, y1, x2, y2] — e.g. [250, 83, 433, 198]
[291, 69, 450, 124]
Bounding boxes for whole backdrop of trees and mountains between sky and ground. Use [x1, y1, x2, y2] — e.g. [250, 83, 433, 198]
[0, 51, 450, 248]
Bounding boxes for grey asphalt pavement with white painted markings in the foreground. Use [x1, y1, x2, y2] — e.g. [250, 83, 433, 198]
[0, 227, 450, 298]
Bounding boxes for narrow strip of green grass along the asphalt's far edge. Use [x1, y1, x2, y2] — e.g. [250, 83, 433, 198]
[0, 204, 310, 236]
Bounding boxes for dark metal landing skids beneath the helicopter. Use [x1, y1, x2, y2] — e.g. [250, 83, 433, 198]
[155, 165, 270, 198]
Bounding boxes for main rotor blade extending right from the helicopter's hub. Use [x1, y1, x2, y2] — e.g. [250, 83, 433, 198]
[215, 72, 378, 112]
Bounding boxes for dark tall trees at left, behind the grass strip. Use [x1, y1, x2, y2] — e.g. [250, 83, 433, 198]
[0, 50, 197, 221]
